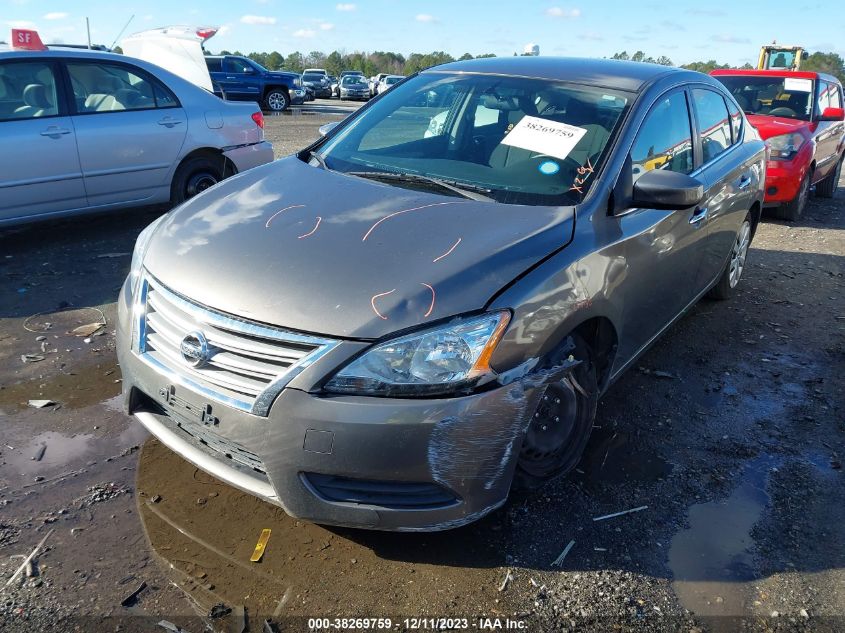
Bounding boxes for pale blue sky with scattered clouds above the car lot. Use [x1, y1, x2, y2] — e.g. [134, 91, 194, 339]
[0, 0, 845, 65]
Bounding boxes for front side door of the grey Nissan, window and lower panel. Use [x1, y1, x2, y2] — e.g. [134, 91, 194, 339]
[618, 89, 705, 358]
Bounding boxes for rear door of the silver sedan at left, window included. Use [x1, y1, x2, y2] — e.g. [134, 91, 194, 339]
[66, 59, 188, 206]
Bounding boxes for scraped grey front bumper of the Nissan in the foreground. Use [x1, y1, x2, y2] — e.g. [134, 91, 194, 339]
[117, 276, 540, 531]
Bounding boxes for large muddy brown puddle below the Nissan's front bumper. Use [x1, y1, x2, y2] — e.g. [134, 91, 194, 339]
[137, 439, 508, 617]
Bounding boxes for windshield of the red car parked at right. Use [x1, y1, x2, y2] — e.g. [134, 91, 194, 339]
[716, 75, 813, 121]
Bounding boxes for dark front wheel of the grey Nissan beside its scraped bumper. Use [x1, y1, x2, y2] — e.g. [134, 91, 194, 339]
[513, 334, 598, 490]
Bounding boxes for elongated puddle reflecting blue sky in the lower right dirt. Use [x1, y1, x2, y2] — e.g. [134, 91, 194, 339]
[669, 455, 778, 617]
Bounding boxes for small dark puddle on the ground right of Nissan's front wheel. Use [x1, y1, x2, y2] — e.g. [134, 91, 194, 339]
[578, 428, 672, 487]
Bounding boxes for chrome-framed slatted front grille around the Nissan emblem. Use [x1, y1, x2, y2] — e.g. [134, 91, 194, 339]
[137, 276, 336, 416]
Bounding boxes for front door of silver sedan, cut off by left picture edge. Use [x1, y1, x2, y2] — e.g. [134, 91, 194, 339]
[0, 58, 86, 222]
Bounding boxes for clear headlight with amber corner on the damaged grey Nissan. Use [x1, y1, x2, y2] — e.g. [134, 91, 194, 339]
[324, 311, 510, 396]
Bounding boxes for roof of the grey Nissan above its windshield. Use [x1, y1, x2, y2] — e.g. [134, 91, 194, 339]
[423, 56, 688, 92]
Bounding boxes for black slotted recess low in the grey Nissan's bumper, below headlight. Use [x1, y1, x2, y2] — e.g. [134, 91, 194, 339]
[303, 473, 458, 510]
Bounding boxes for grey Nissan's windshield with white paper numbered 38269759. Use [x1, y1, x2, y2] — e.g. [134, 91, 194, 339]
[321, 72, 630, 205]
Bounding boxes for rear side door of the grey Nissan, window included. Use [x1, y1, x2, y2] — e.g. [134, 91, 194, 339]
[690, 87, 762, 290]
